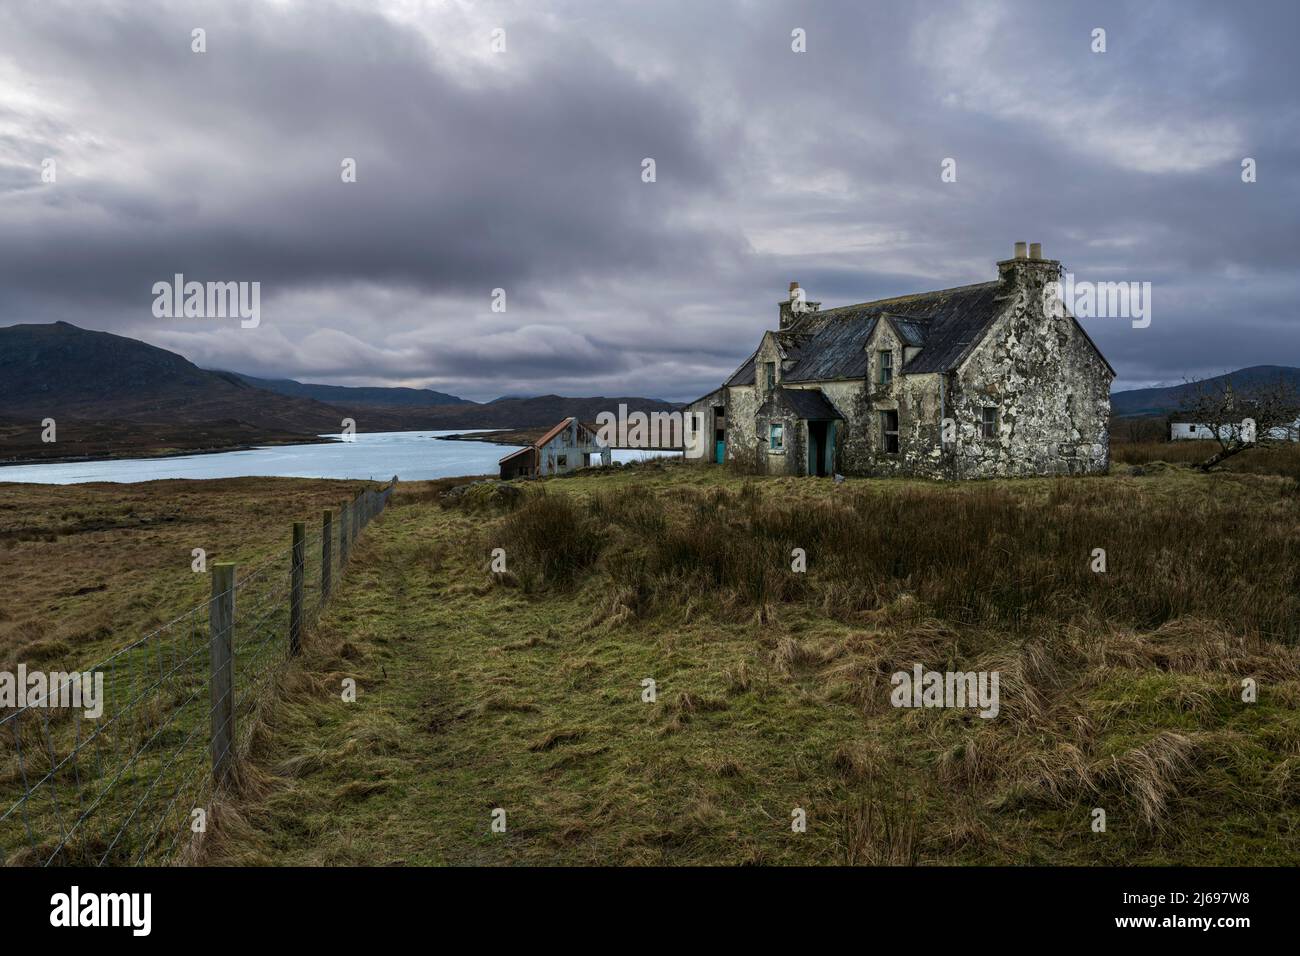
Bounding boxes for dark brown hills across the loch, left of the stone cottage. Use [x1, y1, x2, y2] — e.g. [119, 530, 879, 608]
[0, 323, 677, 460]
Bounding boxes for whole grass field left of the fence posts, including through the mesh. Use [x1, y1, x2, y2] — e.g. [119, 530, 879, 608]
[0, 479, 384, 864]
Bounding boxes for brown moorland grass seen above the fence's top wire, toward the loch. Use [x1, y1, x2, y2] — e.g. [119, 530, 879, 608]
[0, 472, 382, 670]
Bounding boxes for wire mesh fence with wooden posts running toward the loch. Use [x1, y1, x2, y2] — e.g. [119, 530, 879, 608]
[0, 477, 397, 866]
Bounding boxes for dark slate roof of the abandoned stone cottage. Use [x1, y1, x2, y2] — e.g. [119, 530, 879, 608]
[774, 281, 1006, 385]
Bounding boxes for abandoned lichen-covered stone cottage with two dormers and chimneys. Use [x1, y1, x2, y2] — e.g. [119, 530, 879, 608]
[688, 242, 1115, 477]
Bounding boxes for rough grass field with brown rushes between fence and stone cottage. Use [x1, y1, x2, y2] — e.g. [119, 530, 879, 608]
[180, 446, 1300, 865]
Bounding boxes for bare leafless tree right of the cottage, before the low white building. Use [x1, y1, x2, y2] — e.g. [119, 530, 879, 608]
[1179, 375, 1300, 471]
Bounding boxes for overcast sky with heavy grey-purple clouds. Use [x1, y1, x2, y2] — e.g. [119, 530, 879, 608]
[0, 0, 1300, 399]
